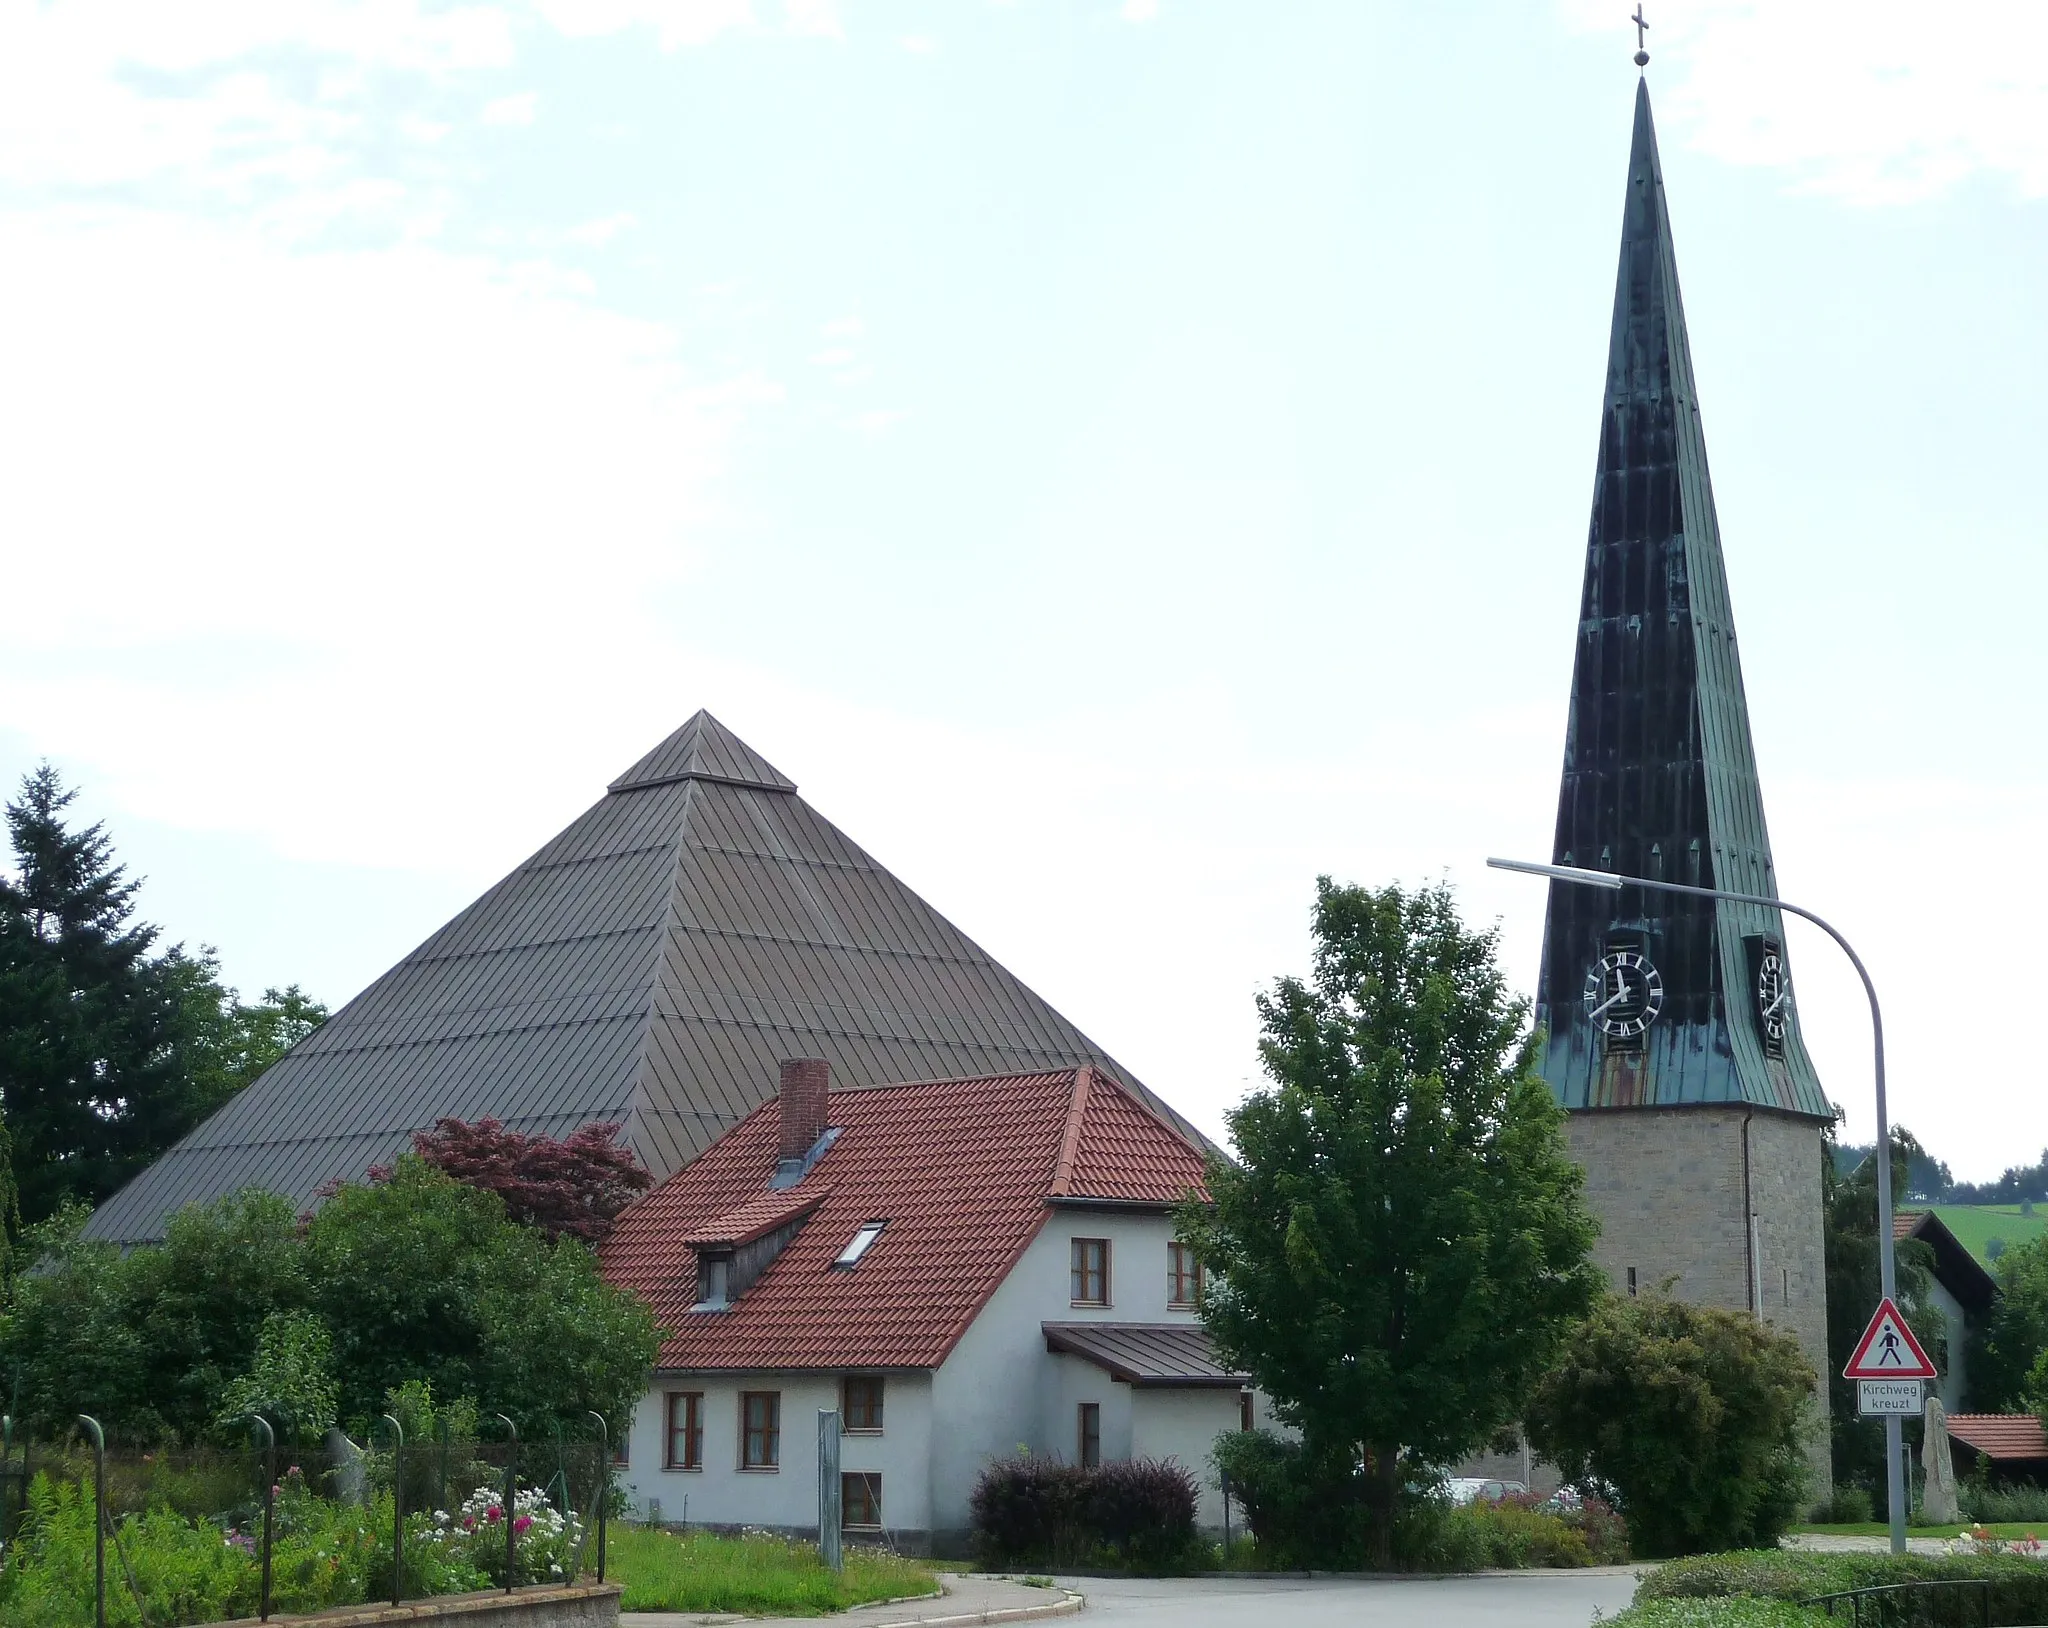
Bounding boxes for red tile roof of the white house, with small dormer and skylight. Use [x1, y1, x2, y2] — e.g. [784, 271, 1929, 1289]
[602, 1067, 1202, 1370]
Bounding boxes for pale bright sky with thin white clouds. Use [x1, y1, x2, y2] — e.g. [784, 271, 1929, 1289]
[0, 0, 2048, 1177]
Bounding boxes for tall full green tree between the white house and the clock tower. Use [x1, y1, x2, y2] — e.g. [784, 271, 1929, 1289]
[1180, 876, 1599, 1565]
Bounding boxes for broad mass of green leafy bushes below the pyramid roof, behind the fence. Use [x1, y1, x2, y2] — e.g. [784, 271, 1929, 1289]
[0, 1155, 657, 1442]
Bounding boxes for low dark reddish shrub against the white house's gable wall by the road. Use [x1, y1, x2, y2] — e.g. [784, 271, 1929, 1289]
[971, 1456, 1198, 1571]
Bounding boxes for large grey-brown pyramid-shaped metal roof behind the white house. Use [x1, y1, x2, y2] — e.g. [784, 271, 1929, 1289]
[88, 713, 1196, 1243]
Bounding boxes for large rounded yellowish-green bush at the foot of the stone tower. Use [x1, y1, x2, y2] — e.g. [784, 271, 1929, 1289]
[1526, 1294, 1817, 1558]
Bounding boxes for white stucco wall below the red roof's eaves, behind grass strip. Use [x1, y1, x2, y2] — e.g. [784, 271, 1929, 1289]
[618, 1372, 932, 1532]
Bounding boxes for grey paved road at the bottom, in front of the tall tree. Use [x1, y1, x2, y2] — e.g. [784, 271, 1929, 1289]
[1061, 1567, 1636, 1628]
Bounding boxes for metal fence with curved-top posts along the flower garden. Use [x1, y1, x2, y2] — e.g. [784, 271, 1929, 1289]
[0, 1413, 616, 1628]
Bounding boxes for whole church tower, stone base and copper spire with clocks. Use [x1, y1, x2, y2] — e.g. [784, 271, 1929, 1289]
[1536, 84, 1831, 1495]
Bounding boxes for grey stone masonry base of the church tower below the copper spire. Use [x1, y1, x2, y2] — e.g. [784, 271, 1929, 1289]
[1567, 1106, 1833, 1501]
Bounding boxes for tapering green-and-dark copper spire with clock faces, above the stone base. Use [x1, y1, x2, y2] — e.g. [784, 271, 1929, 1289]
[1538, 82, 1829, 1118]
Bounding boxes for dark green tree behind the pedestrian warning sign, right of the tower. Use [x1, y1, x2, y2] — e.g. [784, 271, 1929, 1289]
[1821, 1126, 1933, 1497]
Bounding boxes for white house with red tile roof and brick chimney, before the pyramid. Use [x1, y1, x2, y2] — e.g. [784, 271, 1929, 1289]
[602, 1061, 1260, 1554]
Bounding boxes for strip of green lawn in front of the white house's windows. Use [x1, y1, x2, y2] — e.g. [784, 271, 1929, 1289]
[606, 1526, 938, 1616]
